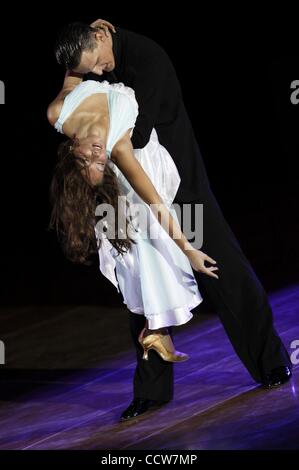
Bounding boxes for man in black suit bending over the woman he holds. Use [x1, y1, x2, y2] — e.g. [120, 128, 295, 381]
[55, 20, 291, 420]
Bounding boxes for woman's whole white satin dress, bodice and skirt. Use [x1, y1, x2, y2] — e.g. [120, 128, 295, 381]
[55, 80, 202, 329]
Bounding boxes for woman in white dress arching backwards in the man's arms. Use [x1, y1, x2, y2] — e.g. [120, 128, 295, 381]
[47, 72, 218, 362]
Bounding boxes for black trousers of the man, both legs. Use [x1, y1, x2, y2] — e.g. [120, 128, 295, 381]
[130, 186, 291, 400]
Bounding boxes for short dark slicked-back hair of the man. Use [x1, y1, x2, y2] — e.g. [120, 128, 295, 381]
[54, 22, 97, 70]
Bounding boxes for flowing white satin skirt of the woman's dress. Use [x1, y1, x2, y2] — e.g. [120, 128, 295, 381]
[98, 129, 202, 329]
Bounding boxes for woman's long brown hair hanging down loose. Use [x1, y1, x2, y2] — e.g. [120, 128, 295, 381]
[49, 140, 136, 264]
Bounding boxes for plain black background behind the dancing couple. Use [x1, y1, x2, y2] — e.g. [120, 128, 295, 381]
[0, 7, 299, 306]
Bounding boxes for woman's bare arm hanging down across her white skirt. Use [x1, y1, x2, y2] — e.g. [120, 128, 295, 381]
[111, 133, 218, 279]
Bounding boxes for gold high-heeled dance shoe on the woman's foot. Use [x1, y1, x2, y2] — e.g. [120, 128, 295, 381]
[138, 328, 189, 362]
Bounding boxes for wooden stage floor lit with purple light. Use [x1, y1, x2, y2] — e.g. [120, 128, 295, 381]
[0, 285, 299, 450]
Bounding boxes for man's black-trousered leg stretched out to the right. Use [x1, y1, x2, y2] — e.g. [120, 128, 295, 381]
[193, 188, 291, 382]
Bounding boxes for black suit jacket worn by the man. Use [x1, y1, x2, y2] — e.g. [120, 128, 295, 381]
[86, 28, 208, 202]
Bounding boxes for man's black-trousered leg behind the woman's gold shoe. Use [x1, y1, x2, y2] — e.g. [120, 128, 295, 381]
[129, 312, 173, 402]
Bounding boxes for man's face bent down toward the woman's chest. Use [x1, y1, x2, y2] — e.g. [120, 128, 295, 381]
[74, 31, 115, 75]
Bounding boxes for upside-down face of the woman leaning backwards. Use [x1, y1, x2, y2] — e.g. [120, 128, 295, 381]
[73, 137, 107, 187]
